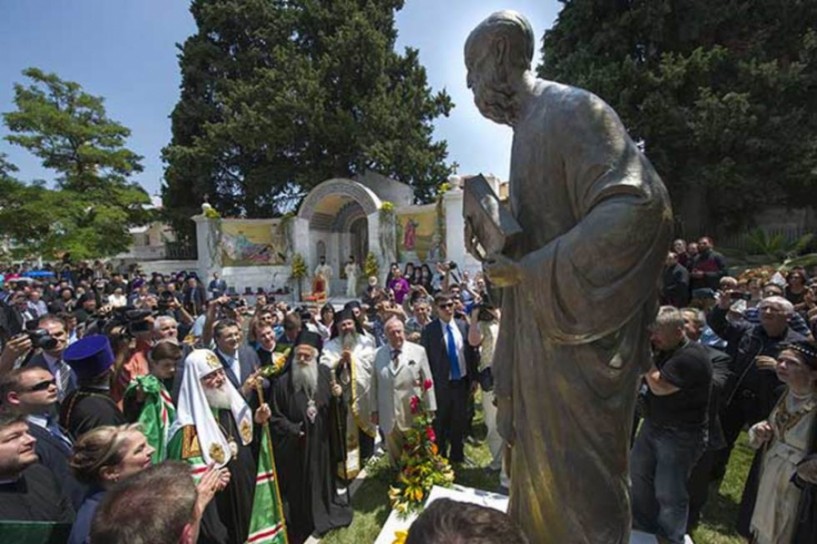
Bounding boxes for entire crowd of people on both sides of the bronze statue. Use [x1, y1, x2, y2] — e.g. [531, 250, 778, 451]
[0, 242, 817, 544]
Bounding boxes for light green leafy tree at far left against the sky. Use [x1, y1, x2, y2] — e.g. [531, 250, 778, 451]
[0, 68, 150, 258]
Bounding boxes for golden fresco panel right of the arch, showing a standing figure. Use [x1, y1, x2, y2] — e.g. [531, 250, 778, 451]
[396, 204, 445, 263]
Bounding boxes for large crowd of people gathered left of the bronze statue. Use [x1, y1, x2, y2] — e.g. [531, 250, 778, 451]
[0, 263, 507, 544]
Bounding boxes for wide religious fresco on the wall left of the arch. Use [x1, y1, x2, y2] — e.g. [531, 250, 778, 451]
[221, 220, 287, 266]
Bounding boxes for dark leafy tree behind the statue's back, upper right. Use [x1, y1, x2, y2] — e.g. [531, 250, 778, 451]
[539, 0, 817, 234]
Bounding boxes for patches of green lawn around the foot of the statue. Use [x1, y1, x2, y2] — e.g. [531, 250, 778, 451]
[321, 405, 753, 544]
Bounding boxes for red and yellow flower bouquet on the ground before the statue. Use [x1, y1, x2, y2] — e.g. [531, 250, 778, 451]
[389, 377, 454, 515]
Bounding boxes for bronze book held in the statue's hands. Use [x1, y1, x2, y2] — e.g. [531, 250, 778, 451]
[462, 174, 522, 261]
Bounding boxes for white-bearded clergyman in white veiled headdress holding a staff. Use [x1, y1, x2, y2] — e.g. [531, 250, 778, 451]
[168, 349, 270, 544]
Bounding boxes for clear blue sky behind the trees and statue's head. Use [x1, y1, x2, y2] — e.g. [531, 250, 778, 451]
[0, 0, 559, 198]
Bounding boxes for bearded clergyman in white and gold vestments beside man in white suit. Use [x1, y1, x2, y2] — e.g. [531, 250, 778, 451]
[320, 308, 377, 480]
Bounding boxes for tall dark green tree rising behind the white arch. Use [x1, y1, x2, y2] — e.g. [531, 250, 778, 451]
[164, 0, 452, 238]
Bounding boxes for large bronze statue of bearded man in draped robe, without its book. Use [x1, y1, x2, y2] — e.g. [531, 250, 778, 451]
[465, 11, 672, 544]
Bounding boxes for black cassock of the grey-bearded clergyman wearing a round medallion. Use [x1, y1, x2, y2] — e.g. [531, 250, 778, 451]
[270, 363, 352, 544]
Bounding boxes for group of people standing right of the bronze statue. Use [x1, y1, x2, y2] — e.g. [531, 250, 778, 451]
[648, 237, 817, 544]
